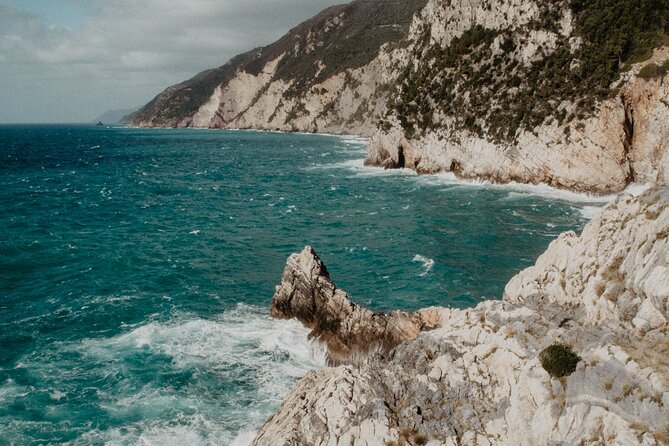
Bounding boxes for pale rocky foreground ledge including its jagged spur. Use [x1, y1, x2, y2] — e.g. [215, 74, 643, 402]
[253, 187, 669, 445]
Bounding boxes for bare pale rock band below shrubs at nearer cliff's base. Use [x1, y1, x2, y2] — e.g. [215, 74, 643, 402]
[365, 40, 669, 193]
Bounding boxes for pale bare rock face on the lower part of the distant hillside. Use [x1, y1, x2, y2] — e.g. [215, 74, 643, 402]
[201, 48, 395, 135]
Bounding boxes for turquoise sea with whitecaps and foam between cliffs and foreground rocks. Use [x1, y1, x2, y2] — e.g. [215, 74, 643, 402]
[0, 126, 592, 444]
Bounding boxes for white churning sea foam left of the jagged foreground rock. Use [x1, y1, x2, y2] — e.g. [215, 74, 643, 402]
[72, 304, 325, 446]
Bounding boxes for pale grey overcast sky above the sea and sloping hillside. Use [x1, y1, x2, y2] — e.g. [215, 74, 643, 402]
[0, 0, 347, 123]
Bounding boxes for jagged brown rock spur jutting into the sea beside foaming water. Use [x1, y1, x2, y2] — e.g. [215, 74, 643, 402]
[270, 246, 442, 365]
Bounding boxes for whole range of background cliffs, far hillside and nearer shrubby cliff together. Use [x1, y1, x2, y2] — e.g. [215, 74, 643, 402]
[128, 0, 669, 192]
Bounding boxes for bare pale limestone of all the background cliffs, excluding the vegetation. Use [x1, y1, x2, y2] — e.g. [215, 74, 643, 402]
[131, 0, 669, 193]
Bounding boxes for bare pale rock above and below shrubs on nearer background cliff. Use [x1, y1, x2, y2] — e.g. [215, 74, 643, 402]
[366, 0, 669, 193]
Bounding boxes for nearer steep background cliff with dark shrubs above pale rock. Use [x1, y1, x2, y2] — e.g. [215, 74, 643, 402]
[367, 0, 669, 192]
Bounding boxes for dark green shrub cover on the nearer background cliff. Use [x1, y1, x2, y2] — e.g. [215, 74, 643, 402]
[381, 0, 669, 143]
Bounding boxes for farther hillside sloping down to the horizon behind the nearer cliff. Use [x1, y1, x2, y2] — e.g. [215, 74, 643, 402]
[128, 0, 427, 134]
